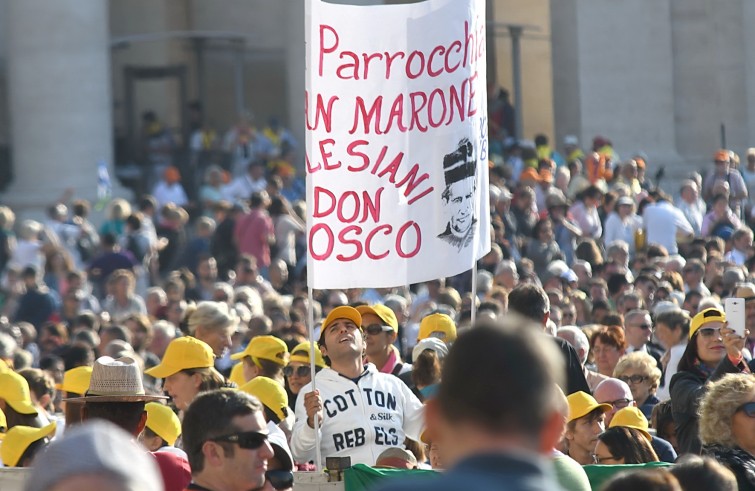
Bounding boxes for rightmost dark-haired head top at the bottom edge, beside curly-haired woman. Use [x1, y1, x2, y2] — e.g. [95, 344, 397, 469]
[669, 454, 739, 491]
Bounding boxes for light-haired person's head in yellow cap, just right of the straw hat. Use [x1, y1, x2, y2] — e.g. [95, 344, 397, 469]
[144, 336, 228, 411]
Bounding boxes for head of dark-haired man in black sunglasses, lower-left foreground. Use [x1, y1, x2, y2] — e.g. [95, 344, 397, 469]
[182, 390, 279, 491]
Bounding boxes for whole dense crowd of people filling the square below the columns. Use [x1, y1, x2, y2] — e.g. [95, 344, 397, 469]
[0, 127, 755, 491]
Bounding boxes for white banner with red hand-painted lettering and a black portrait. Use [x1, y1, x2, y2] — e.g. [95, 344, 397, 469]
[306, 0, 490, 288]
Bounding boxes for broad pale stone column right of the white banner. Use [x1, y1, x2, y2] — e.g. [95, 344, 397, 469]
[551, 0, 681, 179]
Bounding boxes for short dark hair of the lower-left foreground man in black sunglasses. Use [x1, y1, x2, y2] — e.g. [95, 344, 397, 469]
[181, 390, 263, 474]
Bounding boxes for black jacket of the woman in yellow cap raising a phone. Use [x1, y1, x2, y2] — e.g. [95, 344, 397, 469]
[669, 356, 745, 455]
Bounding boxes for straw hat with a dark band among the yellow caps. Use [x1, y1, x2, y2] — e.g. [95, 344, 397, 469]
[66, 356, 167, 402]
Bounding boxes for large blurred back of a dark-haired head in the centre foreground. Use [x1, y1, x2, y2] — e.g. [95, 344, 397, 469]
[437, 315, 565, 440]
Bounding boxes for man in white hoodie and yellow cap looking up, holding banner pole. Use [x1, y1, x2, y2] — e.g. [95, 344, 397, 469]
[291, 306, 424, 465]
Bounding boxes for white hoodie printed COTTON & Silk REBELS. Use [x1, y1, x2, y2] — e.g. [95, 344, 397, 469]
[291, 363, 424, 465]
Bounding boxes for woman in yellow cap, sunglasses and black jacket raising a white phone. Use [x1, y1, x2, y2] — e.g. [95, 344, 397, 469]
[669, 308, 749, 455]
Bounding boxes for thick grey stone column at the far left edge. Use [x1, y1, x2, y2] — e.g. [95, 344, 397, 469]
[3, 0, 115, 216]
